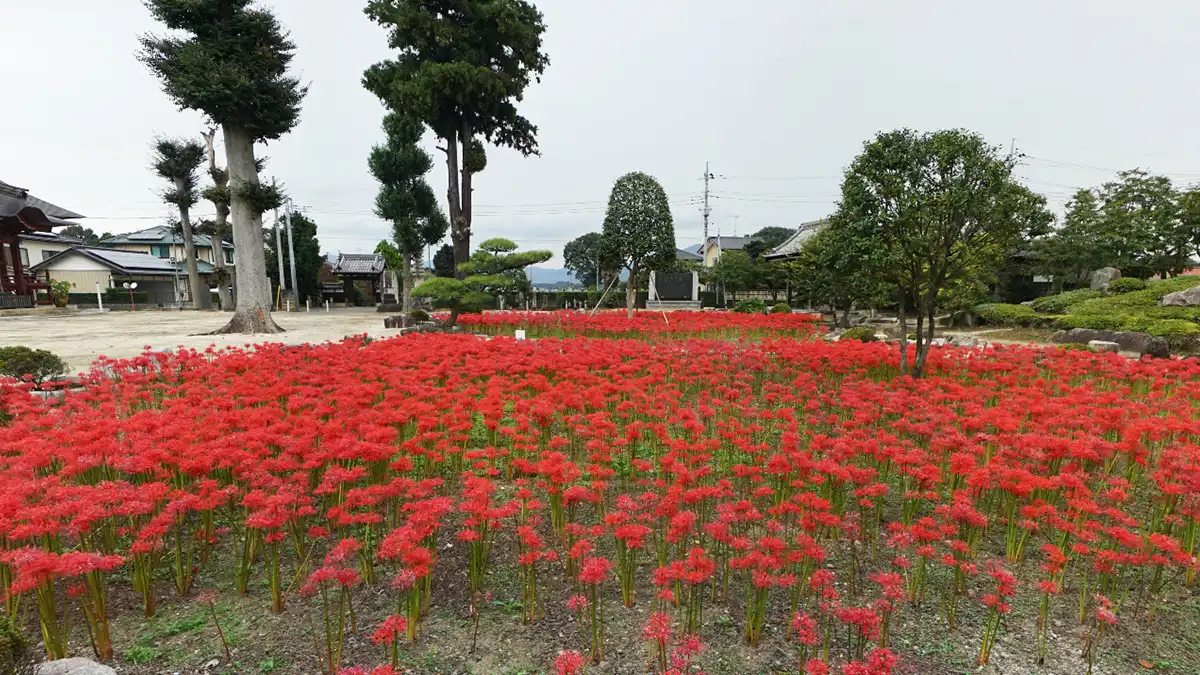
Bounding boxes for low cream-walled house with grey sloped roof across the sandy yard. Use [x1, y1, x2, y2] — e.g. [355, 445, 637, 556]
[30, 246, 214, 306]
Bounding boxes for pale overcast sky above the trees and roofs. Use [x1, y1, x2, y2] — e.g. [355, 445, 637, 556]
[7, 0, 1200, 267]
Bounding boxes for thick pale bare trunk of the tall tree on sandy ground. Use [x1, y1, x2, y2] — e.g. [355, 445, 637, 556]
[208, 125, 283, 334]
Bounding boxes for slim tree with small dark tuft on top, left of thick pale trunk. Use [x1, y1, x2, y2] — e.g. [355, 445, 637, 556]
[150, 138, 210, 310]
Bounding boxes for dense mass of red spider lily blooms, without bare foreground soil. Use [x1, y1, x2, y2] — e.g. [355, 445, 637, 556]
[0, 312, 1200, 673]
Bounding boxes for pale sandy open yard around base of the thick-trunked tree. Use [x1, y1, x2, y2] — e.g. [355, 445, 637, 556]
[0, 307, 396, 372]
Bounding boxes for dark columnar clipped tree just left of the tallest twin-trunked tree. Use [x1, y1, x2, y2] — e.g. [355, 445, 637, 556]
[367, 113, 449, 312]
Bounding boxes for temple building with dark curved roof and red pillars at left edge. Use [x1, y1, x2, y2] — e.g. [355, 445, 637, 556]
[0, 181, 83, 309]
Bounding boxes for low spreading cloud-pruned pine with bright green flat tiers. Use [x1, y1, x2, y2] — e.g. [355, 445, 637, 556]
[413, 238, 553, 327]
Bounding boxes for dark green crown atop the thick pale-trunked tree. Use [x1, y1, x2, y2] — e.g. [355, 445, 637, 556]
[138, 0, 307, 141]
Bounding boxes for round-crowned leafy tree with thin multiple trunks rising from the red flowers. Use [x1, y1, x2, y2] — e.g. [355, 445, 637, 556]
[840, 130, 1054, 376]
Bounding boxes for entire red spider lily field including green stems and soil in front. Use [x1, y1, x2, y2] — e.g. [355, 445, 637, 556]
[0, 312, 1200, 675]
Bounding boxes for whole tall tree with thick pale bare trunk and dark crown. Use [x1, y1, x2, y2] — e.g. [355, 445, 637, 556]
[138, 0, 307, 333]
